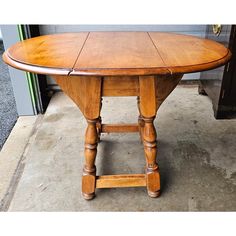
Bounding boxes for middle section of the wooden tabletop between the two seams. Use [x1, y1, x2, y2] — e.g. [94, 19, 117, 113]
[73, 32, 166, 74]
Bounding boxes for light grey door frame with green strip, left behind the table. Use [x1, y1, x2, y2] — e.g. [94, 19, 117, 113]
[0, 25, 43, 116]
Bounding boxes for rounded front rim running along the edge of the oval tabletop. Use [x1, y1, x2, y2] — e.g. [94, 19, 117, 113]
[2, 41, 232, 76]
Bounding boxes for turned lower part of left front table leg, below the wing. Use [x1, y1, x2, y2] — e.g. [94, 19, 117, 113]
[82, 118, 99, 200]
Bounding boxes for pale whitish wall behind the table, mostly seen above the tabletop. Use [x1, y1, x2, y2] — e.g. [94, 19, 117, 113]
[40, 25, 206, 88]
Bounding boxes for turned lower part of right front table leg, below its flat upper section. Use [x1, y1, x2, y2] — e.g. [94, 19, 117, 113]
[143, 117, 160, 197]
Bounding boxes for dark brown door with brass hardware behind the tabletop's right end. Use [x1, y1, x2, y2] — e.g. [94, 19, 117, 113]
[199, 25, 236, 119]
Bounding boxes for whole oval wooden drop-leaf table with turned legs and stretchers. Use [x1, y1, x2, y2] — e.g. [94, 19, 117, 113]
[3, 32, 231, 199]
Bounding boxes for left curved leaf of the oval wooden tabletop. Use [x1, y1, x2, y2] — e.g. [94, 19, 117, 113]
[4, 33, 88, 75]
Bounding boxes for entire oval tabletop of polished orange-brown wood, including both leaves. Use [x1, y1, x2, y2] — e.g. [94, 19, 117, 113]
[3, 32, 231, 76]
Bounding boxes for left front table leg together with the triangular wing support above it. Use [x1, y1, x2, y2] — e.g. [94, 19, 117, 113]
[54, 76, 102, 200]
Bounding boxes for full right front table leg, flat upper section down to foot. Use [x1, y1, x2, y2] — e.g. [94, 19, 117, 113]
[139, 76, 160, 197]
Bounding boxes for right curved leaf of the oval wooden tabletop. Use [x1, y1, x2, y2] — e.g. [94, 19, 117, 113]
[149, 32, 230, 74]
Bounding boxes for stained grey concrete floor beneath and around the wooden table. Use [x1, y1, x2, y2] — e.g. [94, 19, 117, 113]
[2, 86, 236, 211]
